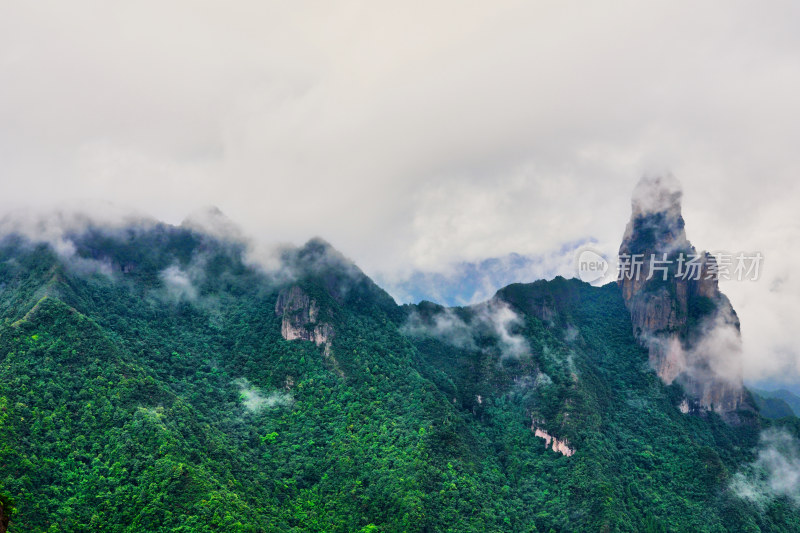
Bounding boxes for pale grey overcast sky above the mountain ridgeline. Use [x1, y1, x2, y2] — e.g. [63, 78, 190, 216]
[0, 0, 800, 386]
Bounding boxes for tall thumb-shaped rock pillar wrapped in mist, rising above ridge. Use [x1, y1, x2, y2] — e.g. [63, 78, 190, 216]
[618, 177, 744, 421]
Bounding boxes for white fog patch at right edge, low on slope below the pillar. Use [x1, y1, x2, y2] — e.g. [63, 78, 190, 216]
[730, 428, 800, 507]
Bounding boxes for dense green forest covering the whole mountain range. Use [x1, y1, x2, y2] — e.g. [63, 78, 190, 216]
[0, 225, 800, 532]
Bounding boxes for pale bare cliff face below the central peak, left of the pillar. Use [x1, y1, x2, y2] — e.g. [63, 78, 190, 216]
[275, 285, 334, 356]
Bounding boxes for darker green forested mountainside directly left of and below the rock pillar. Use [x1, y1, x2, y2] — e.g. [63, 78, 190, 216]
[412, 278, 793, 531]
